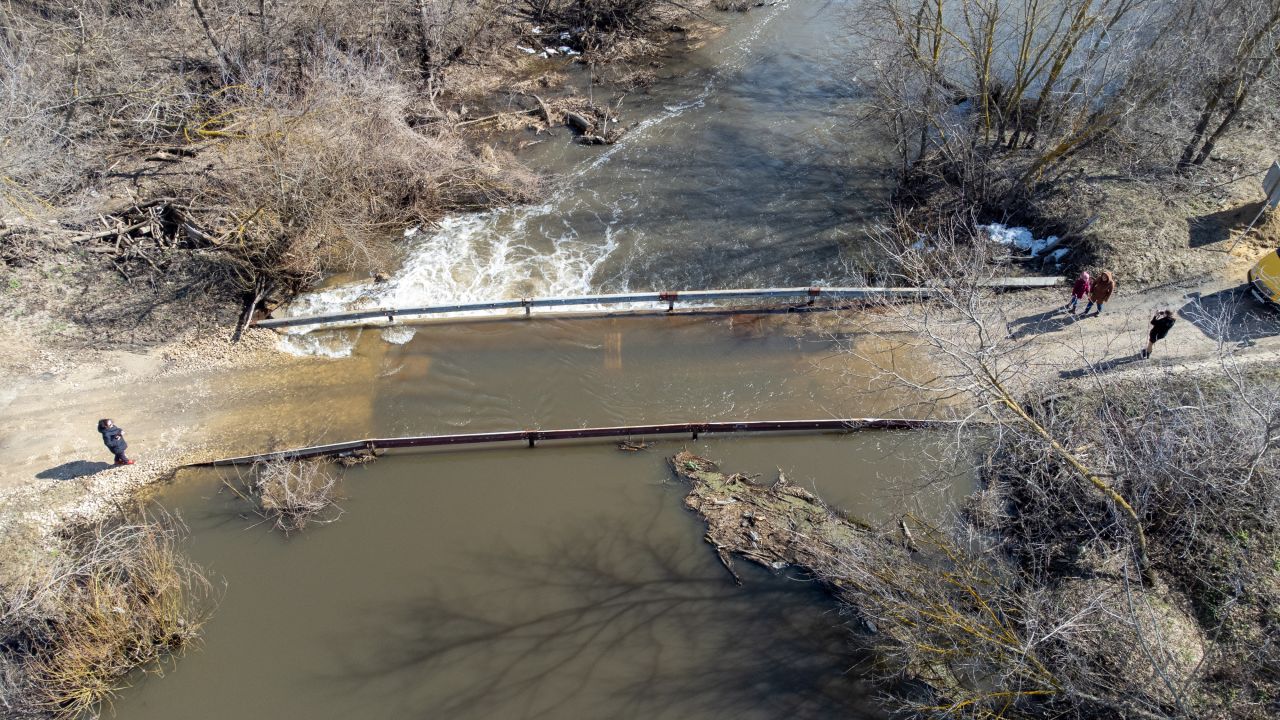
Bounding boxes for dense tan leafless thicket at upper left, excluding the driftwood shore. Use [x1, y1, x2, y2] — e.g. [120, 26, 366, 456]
[0, 0, 536, 308]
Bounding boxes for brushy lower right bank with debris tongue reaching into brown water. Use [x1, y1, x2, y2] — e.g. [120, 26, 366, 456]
[673, 356, 1280, 720]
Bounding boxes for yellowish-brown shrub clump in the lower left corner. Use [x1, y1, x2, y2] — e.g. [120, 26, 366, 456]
[0, 512, 214, 719]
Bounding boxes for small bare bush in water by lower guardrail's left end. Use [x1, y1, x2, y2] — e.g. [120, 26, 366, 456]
[248, 460, 342, 534]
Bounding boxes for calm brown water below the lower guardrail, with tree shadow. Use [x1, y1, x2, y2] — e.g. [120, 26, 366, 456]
[115, 433, 957, 720]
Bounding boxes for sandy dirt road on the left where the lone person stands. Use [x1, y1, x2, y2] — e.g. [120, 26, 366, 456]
[0, 331, 396, 583]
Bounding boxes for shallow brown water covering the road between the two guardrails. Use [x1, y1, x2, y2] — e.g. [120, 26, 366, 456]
[199, 315, 922, 455]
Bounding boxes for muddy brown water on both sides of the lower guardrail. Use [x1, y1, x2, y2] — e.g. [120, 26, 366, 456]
[115, 316, 948, 720]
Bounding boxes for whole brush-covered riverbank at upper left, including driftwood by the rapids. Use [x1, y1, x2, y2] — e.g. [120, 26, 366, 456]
[0, 0, 722, 356]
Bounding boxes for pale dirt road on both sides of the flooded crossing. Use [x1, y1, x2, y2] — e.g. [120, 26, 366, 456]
[0, 258, 1280, 576]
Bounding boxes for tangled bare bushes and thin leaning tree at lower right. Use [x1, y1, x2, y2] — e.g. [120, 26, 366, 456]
[831, 218, 1280, 719]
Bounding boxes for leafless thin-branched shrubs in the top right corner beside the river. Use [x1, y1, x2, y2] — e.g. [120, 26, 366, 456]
[859, 0, 1280, 193]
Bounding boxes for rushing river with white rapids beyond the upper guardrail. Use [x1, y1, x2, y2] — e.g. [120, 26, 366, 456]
[288, 0, 888, 355]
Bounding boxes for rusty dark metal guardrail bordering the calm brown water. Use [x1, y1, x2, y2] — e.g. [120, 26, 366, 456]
[195, 418, 952, 466]
